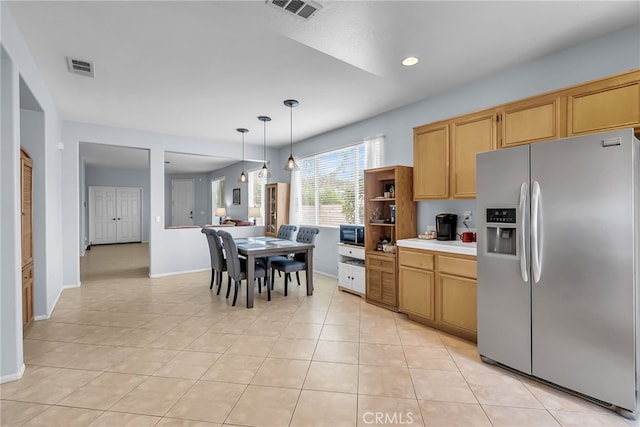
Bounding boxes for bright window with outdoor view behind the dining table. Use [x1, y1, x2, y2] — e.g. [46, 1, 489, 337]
[292, 138, 382, 226]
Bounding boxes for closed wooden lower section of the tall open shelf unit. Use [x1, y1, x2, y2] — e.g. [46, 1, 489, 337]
[366, 252, 398, 311]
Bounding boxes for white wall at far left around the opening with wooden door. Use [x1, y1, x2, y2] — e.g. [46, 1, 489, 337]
[0, 2, 64, 381]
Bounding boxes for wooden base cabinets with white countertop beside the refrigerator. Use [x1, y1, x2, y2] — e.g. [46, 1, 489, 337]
[397, 239, 477, 342]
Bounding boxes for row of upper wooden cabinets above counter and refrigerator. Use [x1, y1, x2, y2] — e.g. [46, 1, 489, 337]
[413, 69, 640, 201]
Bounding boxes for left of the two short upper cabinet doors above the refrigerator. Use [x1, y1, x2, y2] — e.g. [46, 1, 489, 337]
[500, 95, 566, 148]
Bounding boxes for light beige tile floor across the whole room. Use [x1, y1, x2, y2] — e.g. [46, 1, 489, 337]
[0, 244, 639, 427]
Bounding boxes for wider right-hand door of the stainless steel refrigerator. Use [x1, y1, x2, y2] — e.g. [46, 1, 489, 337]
[531, 130, 638, 409]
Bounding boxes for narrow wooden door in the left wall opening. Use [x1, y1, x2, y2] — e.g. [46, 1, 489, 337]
[20, 149, 33, 333]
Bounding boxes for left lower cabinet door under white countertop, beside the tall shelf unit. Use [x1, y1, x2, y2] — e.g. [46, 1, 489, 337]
[399, 266, 435, 320]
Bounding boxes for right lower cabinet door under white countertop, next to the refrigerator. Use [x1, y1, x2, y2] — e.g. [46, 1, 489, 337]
[439, 274, 478, 333]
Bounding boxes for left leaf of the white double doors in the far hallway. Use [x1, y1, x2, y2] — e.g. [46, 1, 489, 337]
[89, 187, 117, 245]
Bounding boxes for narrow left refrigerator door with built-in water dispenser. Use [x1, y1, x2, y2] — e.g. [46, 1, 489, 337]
[476, 145, 531, 374]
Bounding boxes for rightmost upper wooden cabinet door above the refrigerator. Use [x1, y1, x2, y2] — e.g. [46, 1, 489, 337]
[567, 73, 640, 136]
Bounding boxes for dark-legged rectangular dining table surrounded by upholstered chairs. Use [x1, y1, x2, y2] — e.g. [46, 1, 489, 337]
[234, 237, 315, 308]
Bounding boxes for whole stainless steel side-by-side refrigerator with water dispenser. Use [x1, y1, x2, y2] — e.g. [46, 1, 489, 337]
[477, 129, 640, 418]
